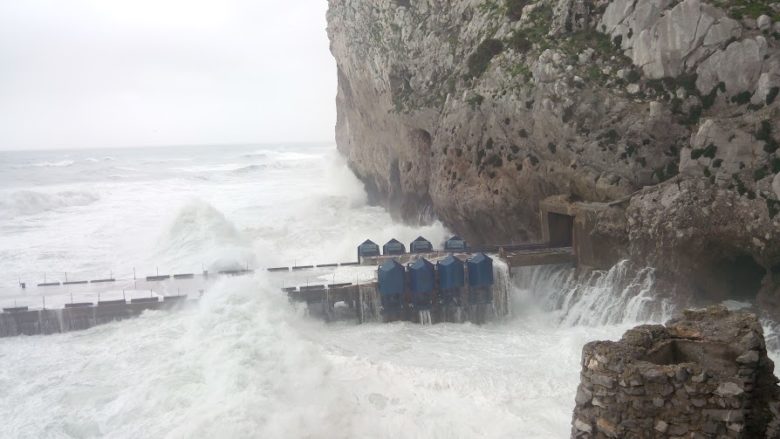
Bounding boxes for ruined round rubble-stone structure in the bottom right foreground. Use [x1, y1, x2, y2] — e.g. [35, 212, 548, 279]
[572, 306, 780, 439]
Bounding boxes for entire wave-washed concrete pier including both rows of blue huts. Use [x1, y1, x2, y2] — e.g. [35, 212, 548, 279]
[0, 236, 548, 337]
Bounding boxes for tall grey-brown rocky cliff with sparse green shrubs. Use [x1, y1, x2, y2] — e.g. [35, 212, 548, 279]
[328, 0, 780, 310]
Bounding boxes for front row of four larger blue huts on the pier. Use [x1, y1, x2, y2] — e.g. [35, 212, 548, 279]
[377, 244, 494, 311]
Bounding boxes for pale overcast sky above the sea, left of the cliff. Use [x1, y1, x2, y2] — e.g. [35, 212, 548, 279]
[0, 0, 336, 150]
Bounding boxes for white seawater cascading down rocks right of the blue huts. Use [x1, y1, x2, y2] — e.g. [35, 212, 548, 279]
[512, 261, 674, 326]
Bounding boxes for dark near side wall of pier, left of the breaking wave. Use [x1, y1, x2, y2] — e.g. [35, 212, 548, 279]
[0, 296, 194, 337]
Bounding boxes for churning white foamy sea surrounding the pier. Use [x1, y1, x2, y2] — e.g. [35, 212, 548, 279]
[0, 145, 756, 438]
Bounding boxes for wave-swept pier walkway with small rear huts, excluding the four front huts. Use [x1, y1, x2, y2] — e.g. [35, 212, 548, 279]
[0, 237, 575, 337]
